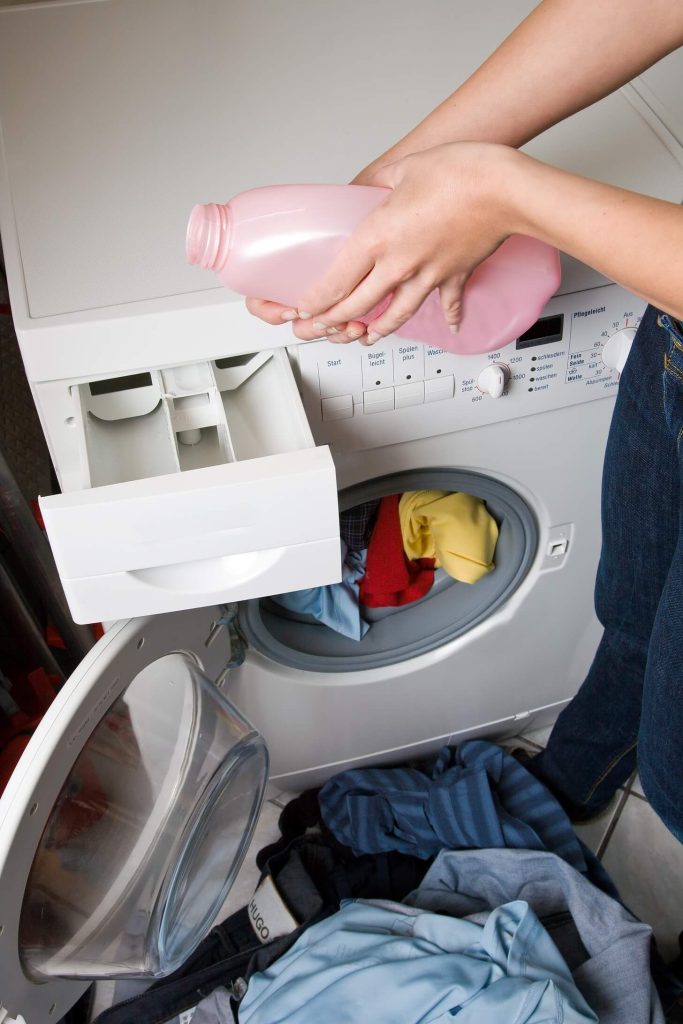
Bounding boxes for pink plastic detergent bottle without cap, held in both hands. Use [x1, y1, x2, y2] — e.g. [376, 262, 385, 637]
[186, 184, 560, 355]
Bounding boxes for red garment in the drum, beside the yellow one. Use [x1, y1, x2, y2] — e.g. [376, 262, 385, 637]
[358, 495, 434, 608]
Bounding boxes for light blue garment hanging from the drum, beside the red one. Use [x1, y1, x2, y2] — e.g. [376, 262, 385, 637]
[272, 541, 370, 640]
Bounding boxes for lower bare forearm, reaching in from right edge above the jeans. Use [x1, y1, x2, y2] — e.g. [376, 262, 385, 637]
[499, 152, 683, 319]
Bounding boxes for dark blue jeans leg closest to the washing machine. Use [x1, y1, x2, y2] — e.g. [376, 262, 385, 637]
[529, 308, 679, 814]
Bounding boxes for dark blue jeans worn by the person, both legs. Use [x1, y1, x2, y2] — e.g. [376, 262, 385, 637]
[529, 307, 683, 842]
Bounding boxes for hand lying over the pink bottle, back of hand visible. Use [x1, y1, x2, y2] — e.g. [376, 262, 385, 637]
[295, 142, 518, 344]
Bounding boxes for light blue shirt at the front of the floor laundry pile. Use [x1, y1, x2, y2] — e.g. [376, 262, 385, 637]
[239, 900, 598, 1024]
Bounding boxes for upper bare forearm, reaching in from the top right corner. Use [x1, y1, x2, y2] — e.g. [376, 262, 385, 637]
[362, 0, 683, 177]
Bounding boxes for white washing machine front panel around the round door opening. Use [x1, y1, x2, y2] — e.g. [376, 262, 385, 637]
[227, 397, 613, 791]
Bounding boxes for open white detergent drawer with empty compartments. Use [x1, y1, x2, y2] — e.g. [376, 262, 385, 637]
[40, 349, 341, 623]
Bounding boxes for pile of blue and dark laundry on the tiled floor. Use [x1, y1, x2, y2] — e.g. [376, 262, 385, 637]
[97, 740, 665, 1024]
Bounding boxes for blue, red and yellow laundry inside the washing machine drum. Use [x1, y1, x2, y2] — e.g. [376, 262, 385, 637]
[272, 490, 498, 640]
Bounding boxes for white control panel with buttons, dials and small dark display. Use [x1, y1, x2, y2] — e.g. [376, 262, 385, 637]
[292, 285, 644, 449]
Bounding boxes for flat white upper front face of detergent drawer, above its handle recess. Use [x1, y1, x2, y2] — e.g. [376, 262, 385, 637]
[40, 449, 339, 579]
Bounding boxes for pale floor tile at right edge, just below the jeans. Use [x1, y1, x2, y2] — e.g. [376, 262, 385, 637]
[602, 796, 683, 959]
